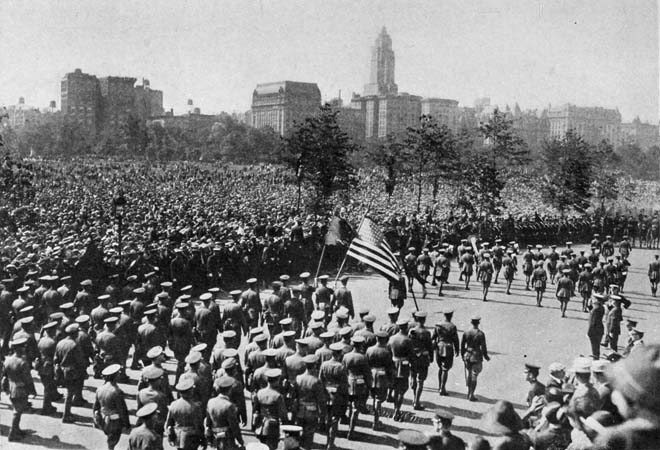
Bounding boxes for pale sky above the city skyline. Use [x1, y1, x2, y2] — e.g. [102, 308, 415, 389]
[0, 0, 660, 122]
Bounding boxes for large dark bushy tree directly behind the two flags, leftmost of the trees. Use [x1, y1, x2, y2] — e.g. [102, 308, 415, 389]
[284, 104, 356, 209]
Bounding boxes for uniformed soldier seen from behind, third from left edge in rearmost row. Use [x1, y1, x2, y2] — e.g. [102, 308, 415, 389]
[53, 323, 87, 423]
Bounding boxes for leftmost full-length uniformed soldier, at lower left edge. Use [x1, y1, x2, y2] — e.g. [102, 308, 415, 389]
[0, 337, 37, 442]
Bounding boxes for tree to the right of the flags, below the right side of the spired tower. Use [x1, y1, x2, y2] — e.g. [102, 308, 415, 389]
[404, 115, 458, 211]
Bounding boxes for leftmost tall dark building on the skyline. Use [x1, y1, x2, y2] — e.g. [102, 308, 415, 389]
[60, 69, 102, 134]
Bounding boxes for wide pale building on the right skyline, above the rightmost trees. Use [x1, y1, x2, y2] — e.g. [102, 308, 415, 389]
[548, 103, 621, 144]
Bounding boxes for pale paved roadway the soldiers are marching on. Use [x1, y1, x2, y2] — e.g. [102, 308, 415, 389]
[0, 248, 660, 450]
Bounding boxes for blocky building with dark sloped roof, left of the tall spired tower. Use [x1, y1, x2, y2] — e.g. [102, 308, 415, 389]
[251, 81, 321, 136]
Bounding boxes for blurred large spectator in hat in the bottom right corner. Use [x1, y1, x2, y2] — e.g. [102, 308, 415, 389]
[594, 345, 660, 450]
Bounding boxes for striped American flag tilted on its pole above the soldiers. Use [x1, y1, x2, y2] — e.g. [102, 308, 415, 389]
[348, 217, 401, 281]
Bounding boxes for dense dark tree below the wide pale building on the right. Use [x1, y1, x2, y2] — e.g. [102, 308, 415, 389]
[543, 130, 595, 213]
